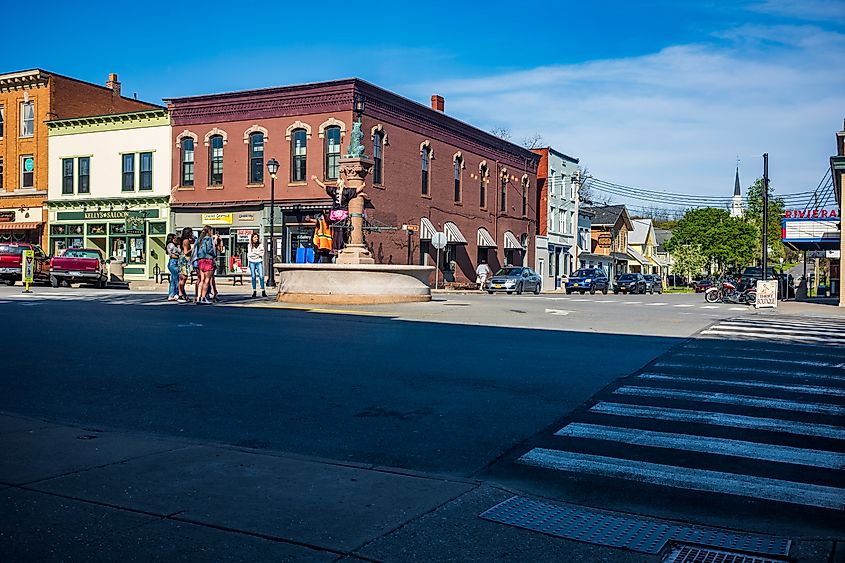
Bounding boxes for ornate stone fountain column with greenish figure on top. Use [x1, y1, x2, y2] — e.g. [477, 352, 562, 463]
[337, 120, 375, 264]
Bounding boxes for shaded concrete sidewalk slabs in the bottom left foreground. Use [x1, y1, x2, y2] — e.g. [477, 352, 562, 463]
[0, 413, 833, 563]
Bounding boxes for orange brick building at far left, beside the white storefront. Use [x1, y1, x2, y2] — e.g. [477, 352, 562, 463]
[0, 69, 157, 247]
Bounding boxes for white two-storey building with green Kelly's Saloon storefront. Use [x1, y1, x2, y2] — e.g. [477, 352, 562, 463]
[47, 109, 172, 280]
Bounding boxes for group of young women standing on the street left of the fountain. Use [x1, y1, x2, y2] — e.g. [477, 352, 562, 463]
[165, 225, 267, 305]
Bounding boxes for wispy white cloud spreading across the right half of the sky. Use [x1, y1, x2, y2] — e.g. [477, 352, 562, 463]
[406, 26, 845, 206]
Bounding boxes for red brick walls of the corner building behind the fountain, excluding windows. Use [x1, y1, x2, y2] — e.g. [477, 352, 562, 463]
[168, 79, 539, 282]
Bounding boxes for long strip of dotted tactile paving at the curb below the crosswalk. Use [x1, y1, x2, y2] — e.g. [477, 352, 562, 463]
[480, 497, 790, 556]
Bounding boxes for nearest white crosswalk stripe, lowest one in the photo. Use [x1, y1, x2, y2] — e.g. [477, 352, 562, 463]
[518, 448, 845, 510]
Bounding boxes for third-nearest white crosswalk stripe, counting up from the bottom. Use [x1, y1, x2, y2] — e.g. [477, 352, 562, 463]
[590, 401, 845, 440]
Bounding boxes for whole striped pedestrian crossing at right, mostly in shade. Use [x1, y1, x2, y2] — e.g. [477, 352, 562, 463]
[517, 314, 845, 514]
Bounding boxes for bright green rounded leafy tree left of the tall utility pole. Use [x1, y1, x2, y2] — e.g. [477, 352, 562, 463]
[665, 207, 756, 271]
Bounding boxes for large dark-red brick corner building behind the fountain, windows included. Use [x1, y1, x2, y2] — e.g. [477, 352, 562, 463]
[167, 79, 539, 282]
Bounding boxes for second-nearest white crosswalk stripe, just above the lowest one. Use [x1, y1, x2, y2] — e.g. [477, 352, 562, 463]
[555, 422, 845, 469]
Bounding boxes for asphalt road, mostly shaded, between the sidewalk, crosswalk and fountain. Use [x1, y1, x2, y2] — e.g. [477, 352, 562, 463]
[0, 288, 740, 476]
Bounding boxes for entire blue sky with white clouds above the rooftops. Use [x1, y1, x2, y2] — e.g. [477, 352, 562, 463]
[8, 0, 845, 204]
